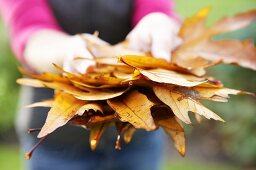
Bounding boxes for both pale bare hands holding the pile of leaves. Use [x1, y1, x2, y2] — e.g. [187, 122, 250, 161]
[24, 13, 181, 73]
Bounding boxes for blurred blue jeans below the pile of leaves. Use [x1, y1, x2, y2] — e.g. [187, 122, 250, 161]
[21, 125, 163, 170]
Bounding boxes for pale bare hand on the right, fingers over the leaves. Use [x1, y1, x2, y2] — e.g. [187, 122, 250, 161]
[126, 12, 182, 61]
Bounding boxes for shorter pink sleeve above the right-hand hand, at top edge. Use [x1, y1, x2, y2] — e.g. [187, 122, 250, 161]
[132, 0, 179, 26]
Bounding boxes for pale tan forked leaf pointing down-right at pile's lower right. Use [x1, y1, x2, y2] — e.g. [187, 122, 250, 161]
[153, 86, 224, 124]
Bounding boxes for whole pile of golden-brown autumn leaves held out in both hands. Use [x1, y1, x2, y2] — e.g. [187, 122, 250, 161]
[17, 8, 256, 157]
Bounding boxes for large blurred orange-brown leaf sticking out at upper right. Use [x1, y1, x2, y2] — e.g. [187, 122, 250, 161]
[172, 9, 256, 76]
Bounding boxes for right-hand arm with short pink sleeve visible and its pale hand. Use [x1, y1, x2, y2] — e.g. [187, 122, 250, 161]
[127, 0, 181, 61]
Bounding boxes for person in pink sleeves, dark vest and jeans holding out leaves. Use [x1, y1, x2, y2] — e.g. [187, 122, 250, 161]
[0, 0, 181, 170]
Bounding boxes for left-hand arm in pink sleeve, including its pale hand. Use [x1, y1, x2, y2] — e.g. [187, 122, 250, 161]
[0, 0, 94, 72]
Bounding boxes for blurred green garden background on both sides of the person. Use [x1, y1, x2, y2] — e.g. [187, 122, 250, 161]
[0, 0, 256, 170]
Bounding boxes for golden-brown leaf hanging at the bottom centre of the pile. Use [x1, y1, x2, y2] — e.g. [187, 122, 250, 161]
[107, 91, 156, 131]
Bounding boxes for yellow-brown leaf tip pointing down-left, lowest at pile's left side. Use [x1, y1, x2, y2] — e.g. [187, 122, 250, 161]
[38, 92, 85, 138]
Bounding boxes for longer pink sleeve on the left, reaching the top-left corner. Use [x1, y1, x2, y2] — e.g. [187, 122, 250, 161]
[0, 0, 61, 64]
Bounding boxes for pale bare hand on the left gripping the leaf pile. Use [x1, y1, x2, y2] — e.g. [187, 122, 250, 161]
[24, 30, 95, 73]
